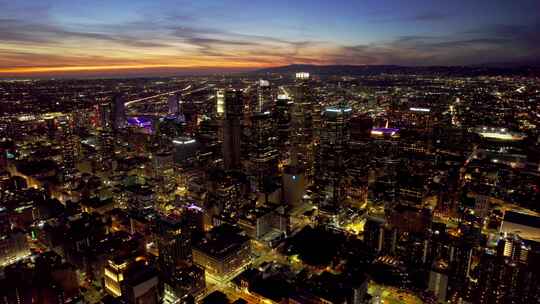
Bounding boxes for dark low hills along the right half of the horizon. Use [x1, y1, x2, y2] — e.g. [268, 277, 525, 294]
[252, 64, 540, 76]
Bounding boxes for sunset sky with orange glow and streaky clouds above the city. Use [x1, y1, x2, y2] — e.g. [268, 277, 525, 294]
[0, 0, 540, 76]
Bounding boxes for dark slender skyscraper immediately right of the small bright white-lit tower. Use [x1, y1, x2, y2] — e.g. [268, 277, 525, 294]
[223, 90, 244, 170]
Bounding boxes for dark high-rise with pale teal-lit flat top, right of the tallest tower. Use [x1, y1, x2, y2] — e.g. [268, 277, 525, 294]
[315, 104, 352, 207]
